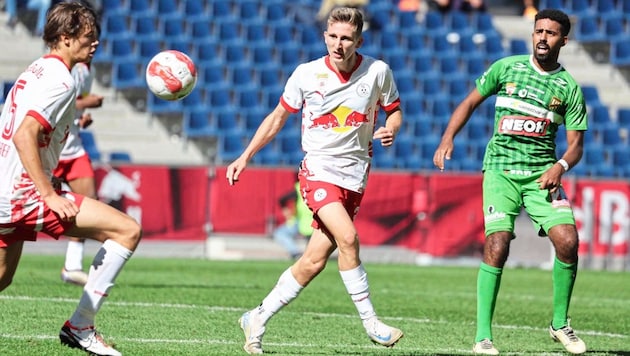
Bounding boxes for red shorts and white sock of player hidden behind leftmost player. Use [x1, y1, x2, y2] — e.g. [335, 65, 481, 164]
[61, 174, 96, 286]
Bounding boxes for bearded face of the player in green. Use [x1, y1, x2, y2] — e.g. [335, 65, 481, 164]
[532, 19, 567, 69]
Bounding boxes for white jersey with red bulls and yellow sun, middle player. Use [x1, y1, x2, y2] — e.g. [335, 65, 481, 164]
[280, 55, 400, 193]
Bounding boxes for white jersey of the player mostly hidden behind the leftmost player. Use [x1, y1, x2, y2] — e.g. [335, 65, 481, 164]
[59, 63, 94, 161]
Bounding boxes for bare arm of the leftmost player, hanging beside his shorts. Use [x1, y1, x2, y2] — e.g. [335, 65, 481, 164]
[13, 115, 79, 219]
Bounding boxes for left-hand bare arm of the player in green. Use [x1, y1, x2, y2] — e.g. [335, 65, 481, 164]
[433, 88, 485, 171]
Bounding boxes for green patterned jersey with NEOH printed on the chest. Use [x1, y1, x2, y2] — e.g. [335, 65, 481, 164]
[476, 55, 587, 171]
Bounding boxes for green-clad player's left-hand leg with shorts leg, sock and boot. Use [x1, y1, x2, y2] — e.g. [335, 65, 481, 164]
[473, 171, 522, 355]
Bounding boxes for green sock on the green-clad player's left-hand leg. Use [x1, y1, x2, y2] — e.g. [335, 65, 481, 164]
[475, 262, 503, 342]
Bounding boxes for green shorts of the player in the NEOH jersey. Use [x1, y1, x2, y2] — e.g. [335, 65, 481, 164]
[483, 171, 575, 236]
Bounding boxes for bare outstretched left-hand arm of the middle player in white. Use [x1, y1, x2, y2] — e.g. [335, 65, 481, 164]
[225, 104, 291, 185]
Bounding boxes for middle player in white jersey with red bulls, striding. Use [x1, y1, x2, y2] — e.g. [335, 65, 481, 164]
[226, 7, 403, 354]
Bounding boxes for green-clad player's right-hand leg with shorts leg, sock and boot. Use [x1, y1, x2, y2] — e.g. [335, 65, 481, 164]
[527, 188, 586, 354]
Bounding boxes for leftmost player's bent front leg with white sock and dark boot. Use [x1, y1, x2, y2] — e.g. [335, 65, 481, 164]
[59, 197, 142, 355]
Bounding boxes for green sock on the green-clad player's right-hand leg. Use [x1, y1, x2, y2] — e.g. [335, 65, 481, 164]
[551, 257, 577, 330]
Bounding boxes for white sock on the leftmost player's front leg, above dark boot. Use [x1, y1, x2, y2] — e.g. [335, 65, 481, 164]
[70, 240, 133, 328]
